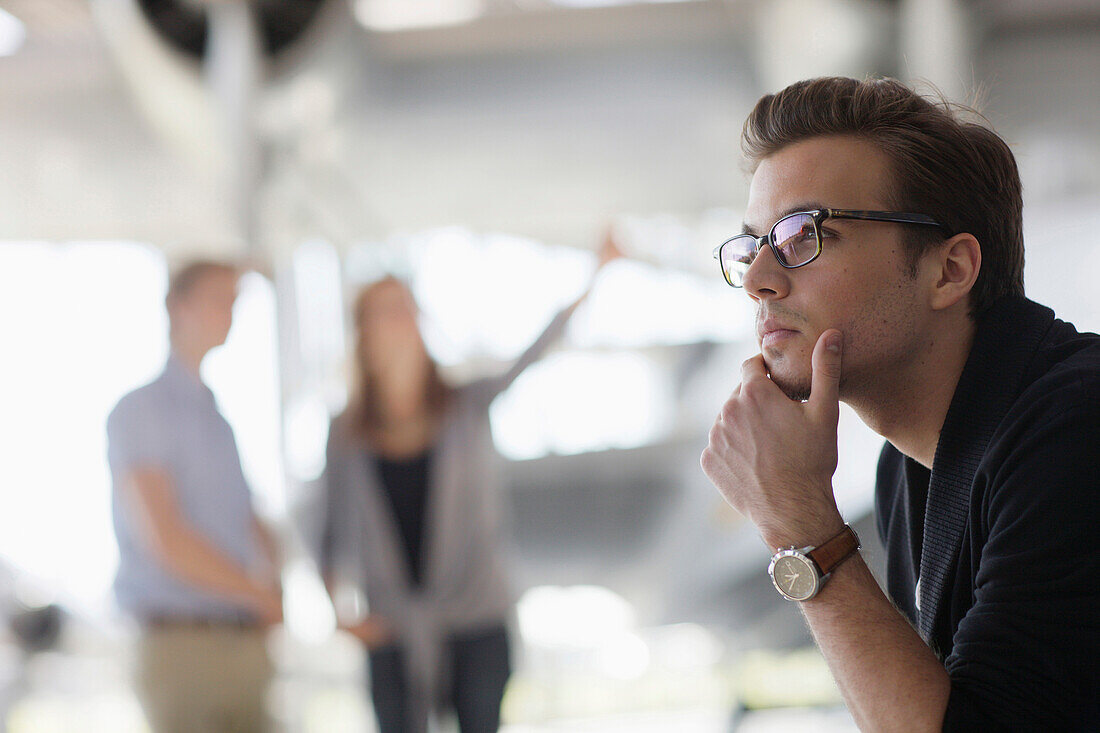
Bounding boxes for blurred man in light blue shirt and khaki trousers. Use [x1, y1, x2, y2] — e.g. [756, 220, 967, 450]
[107, 261, 283, 733]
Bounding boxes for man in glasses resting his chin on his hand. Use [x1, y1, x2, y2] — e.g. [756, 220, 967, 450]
[701, 78, 1100, 731]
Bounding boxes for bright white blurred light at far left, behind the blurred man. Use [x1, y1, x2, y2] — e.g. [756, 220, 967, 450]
[0, 242, 167, 611]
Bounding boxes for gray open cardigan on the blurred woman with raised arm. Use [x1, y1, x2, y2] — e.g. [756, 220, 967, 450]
[320, 306, 575, 730]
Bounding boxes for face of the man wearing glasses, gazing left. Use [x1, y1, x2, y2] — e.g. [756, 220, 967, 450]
[745, 136, 928, 400]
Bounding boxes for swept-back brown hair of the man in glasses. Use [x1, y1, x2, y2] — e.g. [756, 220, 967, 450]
[741, 77, 1024, 316]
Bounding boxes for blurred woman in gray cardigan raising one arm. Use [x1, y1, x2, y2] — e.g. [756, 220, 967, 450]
[321, 237, 618, 733]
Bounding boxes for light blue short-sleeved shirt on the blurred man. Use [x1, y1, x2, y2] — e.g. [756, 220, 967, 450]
[107, 355, 261, 620]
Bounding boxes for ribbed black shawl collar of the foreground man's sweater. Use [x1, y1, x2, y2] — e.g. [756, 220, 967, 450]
[917, 296, 1054, 639]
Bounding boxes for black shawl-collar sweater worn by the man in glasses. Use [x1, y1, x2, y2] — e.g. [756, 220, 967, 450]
[876, 298, 1100, 731]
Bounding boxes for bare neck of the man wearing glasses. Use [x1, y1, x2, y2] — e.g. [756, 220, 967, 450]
[849, 318, 976, 469]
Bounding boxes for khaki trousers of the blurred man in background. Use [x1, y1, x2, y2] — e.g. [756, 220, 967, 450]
[136, 626, 272, 733]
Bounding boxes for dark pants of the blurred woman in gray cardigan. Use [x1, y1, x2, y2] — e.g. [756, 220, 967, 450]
[371, 625, 512, 733]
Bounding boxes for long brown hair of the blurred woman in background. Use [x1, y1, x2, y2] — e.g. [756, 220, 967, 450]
[340, 275, 450, 440]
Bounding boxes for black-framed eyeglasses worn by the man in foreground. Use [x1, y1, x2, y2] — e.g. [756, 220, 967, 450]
[714, 209, 943, 287]
